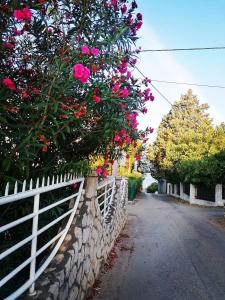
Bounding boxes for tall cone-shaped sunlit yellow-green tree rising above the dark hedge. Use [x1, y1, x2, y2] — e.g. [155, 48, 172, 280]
[148, 90, 218, 182]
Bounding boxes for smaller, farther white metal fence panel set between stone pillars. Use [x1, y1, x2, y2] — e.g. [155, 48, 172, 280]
[97, 177, 116, 219]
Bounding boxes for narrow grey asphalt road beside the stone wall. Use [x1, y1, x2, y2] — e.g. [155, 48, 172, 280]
[94, 195, 225, 300]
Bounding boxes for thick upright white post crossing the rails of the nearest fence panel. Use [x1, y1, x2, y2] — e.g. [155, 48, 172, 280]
[29, 194, 40, 296]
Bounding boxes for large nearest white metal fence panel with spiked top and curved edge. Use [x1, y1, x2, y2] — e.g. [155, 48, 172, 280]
[0, 174, 84, 300]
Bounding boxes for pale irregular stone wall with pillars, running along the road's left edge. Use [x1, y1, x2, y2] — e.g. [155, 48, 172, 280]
[32, 176, 128, 300]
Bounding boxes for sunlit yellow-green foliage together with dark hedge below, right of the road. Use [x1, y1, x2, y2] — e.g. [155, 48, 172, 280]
[148, 90, 225, 184]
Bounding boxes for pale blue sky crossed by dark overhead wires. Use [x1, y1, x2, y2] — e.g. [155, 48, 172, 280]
[137, 0, 225, 140]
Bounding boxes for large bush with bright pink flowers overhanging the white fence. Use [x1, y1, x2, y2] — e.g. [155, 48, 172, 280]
[0, 0, 154, 182]
